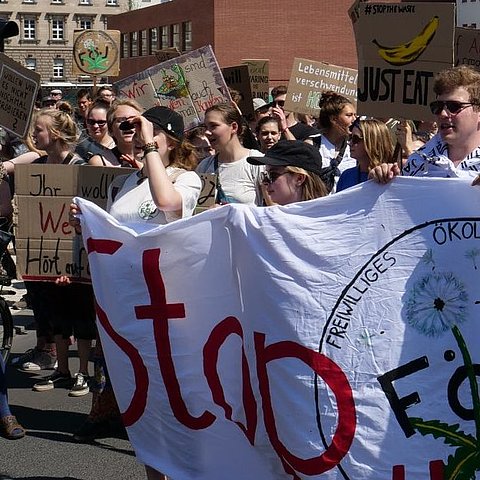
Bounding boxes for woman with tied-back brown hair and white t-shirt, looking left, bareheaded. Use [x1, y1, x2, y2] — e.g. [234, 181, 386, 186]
[196, 103, 263, 205]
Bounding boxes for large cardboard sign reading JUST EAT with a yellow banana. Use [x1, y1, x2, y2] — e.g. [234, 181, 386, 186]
[351, 2, 455, 120]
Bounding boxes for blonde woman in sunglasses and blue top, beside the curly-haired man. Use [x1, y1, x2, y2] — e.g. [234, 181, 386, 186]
[337, 119, 394, 192]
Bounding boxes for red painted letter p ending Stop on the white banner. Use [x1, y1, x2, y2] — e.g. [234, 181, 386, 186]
[254, 332, 356, 476]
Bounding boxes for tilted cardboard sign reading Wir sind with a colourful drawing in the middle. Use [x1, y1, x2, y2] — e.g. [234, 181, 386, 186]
[113, 45, 231, 129]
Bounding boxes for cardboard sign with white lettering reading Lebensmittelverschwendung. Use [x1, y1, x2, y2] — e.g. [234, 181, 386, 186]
[285, 58, 358, 117]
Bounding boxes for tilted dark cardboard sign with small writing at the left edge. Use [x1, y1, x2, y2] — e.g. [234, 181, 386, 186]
[0, 53, 40, 137]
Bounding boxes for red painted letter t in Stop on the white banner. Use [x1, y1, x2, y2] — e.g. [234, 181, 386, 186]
[135, 248, 216, 430]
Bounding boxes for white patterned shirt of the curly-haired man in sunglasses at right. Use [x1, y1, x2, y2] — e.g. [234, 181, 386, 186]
[402, 133, 480, 178]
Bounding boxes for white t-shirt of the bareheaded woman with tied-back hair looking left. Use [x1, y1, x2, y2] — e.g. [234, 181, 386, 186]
[196, 150, 264, 205]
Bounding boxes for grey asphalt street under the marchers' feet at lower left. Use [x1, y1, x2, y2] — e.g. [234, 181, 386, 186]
[0, 282, 145, 480]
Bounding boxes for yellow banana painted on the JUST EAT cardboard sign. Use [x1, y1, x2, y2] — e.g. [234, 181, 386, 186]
[372, 16, 440, 65]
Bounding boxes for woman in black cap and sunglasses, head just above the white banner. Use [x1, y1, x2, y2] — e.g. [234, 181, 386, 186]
[248, 140, 328, 205]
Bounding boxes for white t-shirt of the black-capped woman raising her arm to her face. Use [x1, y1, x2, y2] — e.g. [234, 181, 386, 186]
[107, 167, 202, 225]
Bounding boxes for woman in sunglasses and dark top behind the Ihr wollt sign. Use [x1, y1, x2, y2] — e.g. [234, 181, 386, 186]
[75, 100, 118, 166]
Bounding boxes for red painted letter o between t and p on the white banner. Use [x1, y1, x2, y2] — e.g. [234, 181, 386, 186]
[203, 317, 257, 445]
